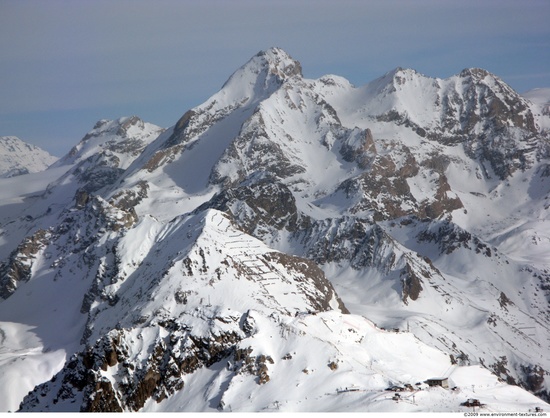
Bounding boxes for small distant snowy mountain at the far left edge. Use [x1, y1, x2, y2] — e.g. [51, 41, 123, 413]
[0, 136, 57, 178]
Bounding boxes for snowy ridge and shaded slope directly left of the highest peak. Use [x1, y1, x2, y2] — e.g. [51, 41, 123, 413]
[0, 116, 164, 276]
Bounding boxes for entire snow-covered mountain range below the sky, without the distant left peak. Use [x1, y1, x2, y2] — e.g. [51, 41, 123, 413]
[0, 48, 550, 412]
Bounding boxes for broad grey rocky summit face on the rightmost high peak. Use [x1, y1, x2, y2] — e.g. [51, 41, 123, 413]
[377, 68, 548, 179]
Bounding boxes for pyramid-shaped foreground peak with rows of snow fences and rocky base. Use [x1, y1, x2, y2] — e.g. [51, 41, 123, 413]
[21, 210, 354, 412]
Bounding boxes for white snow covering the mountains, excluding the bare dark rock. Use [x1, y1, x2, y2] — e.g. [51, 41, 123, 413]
[0, 49, 550, 412]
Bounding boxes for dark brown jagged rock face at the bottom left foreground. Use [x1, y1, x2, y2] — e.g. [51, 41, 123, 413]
[22, 322, 241, 412]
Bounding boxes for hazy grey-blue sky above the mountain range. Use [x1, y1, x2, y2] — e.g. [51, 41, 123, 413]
[0, 0, 550, 156]
